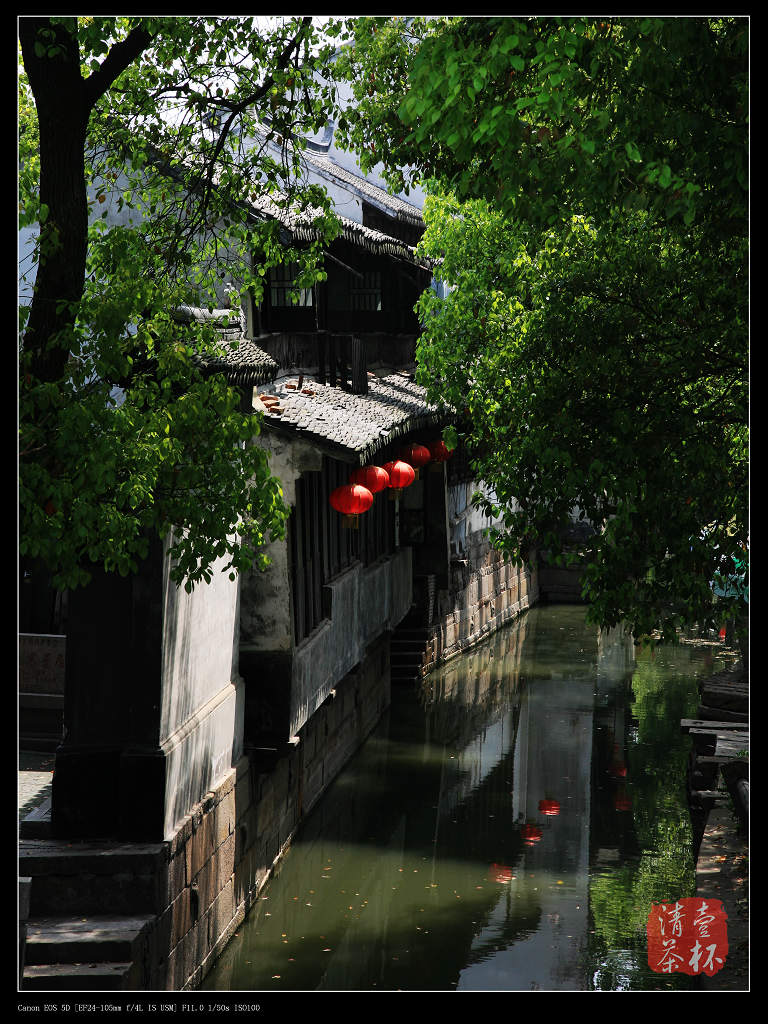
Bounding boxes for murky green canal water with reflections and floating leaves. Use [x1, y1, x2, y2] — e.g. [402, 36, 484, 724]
[202, 605, 741, 992]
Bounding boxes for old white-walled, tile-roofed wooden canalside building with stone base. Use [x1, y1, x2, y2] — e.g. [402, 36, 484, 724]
[19, 128, 538, 989]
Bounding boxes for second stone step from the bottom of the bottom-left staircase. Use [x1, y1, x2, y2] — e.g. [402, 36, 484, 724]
[25, 914, 155, 967]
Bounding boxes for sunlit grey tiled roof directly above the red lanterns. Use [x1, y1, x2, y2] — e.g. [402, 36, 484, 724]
[259, 373, 447, 466]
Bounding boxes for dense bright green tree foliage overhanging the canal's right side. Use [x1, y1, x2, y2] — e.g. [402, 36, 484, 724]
[333, 17, 749, 638]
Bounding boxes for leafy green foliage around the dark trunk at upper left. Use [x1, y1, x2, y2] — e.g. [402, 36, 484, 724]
[19, 16, 336, 587]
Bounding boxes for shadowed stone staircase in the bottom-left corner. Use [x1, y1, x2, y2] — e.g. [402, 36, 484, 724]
[18, 838, 164, 991]
